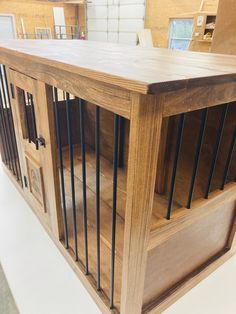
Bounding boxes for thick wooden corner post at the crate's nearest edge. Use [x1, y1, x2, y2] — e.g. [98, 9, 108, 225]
[121, 93, 162, 314]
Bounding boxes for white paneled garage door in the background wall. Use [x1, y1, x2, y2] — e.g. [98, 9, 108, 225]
[86, 0, 145, 45]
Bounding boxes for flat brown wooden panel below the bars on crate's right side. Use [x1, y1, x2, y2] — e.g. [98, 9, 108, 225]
[143, 200, 236, 305]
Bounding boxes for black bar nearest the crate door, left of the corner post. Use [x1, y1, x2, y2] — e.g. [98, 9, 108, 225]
[54, 87, 69, 249]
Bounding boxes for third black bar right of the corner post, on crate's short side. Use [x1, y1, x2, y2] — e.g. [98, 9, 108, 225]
[205, 104, 229, 198]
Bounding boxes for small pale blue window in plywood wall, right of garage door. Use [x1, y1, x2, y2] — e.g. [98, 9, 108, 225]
[169, 19, 193, 50]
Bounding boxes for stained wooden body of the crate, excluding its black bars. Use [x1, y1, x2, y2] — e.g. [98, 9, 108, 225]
[0, 40, 236, 314]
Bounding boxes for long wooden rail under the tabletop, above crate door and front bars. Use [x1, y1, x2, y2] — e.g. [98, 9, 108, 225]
[0, 52, 131, 118]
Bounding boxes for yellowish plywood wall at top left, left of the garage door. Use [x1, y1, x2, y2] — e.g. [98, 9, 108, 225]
[0, 0, 77, 38]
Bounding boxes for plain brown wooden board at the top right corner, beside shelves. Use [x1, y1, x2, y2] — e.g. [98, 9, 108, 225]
[211, 0, 236, 54]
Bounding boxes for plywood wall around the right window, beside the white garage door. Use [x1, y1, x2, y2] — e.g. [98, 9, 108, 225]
[145, 0, 218, 47]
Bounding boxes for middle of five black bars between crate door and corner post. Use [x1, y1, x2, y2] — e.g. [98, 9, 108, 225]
[79, 99, 89, 275]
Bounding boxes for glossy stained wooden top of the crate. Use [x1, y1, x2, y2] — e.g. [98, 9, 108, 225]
[0, 40, 236, 94]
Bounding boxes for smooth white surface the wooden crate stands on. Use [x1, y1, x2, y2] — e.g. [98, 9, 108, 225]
[0, 164, 236, 314]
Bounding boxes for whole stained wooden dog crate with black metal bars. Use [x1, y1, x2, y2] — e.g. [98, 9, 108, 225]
[0, 40, 236, 314]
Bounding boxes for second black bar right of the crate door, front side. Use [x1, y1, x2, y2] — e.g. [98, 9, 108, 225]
[66, 93, 78, 261]
